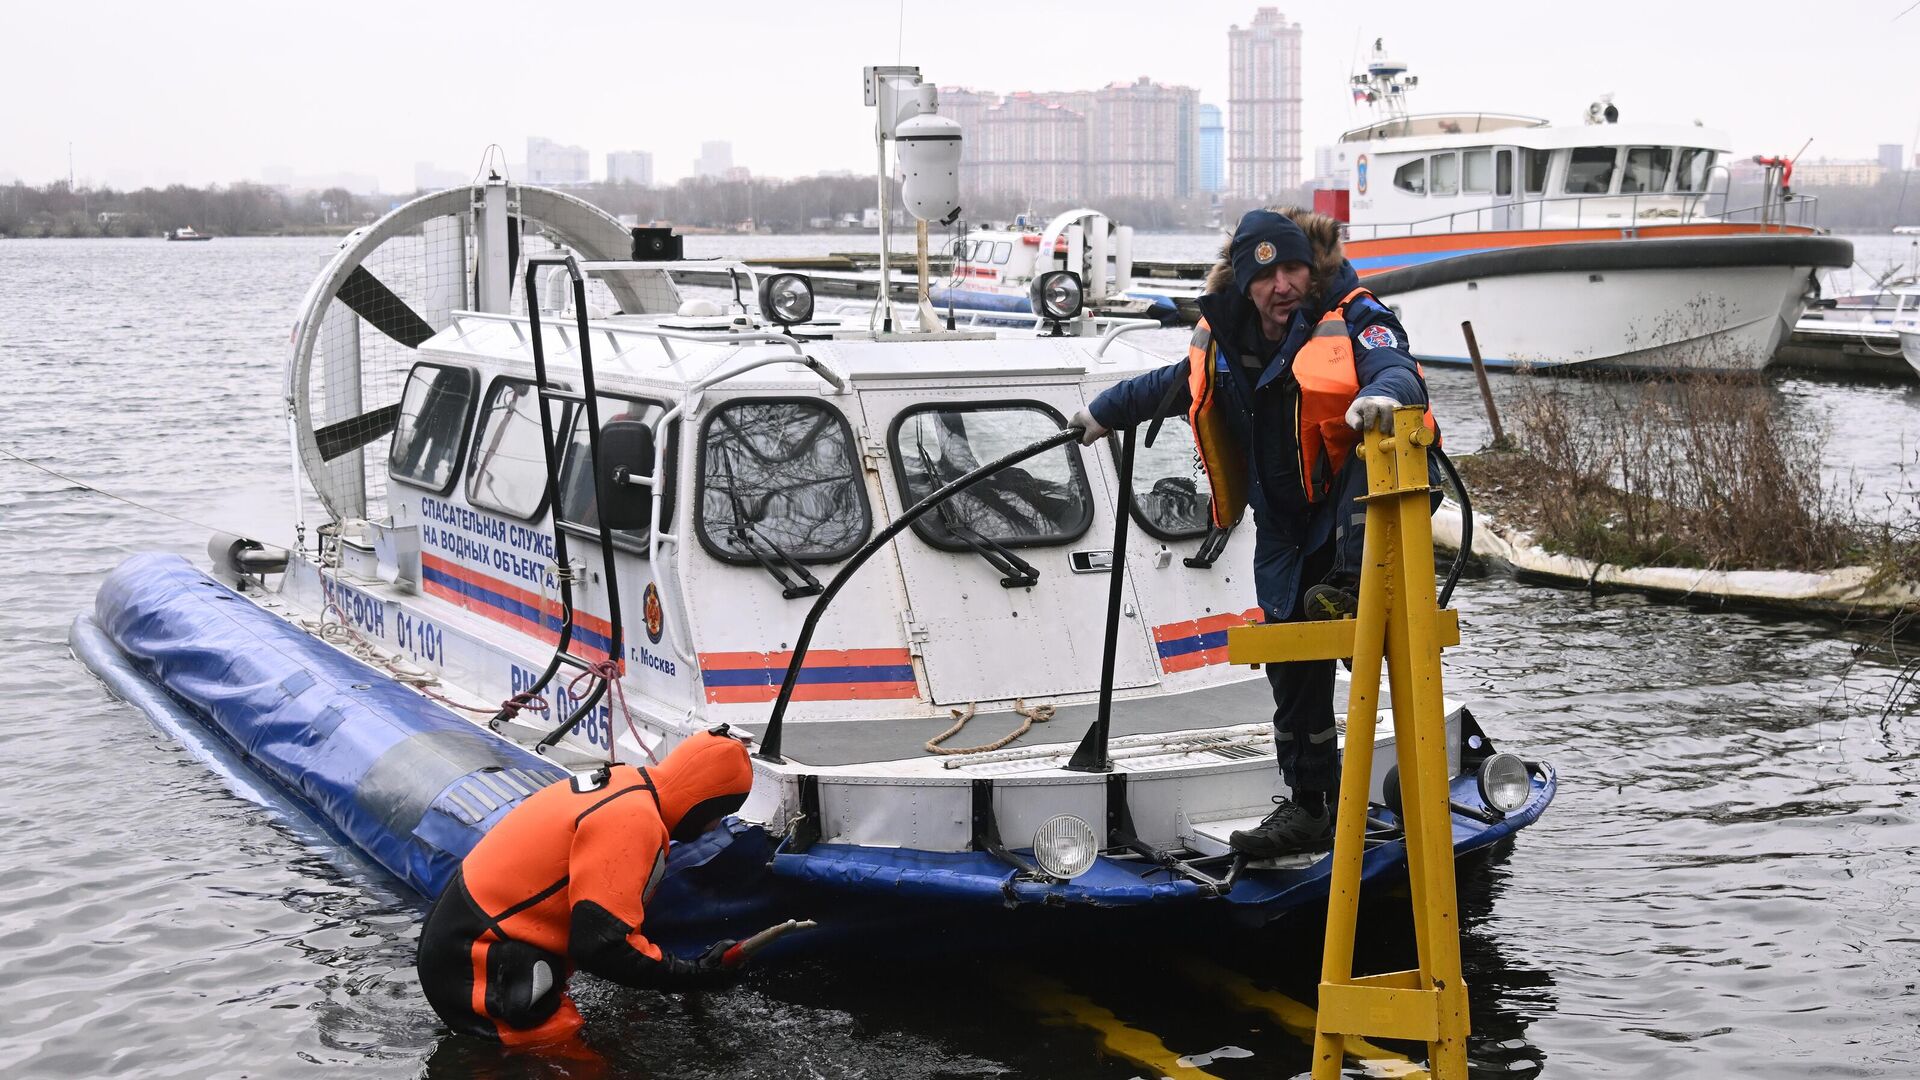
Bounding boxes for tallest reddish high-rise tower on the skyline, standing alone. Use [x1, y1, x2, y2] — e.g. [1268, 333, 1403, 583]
[1227, 8, 1300, 198]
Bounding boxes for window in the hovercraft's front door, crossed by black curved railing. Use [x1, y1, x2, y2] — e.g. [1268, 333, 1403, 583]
[891, 402, 1092, 552]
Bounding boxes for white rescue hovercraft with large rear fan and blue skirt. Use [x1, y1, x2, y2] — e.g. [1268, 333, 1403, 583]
[73, 67, 1555, 940]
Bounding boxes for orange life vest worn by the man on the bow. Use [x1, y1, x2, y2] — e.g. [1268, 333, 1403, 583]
[1187, 288, 1438, 528]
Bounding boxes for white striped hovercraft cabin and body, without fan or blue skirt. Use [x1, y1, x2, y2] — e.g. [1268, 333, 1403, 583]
[274, 265, 1459, 853]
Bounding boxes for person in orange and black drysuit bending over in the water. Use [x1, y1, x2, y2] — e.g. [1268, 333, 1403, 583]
[417, 732, 753, 1045]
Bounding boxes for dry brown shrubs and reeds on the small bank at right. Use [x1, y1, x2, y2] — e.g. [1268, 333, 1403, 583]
[1471, 373, 1870, 571]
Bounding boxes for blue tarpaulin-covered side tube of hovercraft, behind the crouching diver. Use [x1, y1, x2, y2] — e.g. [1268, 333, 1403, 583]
[94, 553, 566, 897]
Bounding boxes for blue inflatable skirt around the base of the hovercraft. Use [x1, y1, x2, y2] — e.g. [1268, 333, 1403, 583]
[71, 555, 1557, 945]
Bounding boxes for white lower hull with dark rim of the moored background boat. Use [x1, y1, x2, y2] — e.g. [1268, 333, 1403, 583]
[1354, 236, 1853, 373]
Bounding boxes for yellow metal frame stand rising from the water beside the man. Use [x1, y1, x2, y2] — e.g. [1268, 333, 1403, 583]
[1227, 405, 1467, 1080]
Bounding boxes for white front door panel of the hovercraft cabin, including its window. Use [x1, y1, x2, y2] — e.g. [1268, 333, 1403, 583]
[862, 384, 1158, 705]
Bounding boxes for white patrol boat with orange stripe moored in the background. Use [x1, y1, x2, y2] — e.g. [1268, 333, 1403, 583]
[1323, 42, 1853, 371]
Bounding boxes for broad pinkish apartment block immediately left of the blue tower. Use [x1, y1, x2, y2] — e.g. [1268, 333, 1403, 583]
[1085, 77, 1200, 198]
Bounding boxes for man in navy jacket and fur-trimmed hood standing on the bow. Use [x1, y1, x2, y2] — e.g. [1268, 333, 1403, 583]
[1073, 208, 1427, 859]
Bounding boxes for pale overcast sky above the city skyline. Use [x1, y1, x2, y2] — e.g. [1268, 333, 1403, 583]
[0, 0, 1920, 190]
